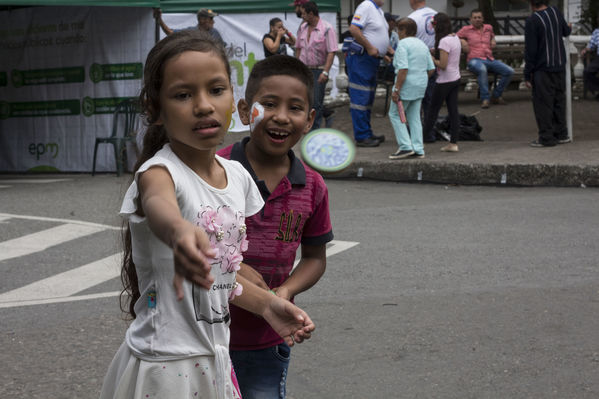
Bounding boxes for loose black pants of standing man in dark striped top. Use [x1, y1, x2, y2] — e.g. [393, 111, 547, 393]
[532, 71, 568, 145]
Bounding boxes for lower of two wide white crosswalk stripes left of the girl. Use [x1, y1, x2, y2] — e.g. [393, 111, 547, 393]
[0, 254, 122, 307]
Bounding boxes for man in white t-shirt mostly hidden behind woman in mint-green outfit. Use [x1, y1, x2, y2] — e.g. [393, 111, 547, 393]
[408, 0, 437, 143]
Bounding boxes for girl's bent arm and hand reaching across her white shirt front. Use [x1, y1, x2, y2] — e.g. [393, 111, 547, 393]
[138, 166, 215, 300]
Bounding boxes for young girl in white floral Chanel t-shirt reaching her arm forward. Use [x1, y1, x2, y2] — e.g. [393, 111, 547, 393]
[100, 30, 314, 399]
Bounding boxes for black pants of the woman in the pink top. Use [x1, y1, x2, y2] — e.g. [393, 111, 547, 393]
[422, 79, 460, 144]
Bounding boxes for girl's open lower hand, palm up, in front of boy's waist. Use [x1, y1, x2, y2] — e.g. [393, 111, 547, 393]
[262, 295, 315, 346]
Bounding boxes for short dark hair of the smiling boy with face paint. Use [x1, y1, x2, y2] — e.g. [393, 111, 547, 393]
[245, 54, 314, 109]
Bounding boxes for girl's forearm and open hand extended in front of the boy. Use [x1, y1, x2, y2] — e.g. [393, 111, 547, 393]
[231, 274, 315, 346]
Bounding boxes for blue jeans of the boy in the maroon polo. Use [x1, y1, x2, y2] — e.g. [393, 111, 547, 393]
[229, 342, 291, 399]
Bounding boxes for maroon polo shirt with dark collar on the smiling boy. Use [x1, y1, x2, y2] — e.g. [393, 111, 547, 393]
[218, 137, 333, 350]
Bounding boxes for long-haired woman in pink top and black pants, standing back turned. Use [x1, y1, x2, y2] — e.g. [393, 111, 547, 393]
[423, 12, 462, 152]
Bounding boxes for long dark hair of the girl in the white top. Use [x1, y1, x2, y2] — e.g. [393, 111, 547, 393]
[120, 29, 231, 319]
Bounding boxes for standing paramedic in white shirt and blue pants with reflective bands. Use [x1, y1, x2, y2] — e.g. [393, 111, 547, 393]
[346, 0, 390, 147]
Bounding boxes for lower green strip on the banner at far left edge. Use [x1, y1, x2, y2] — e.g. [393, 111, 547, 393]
[0, 100, 80, 119]
